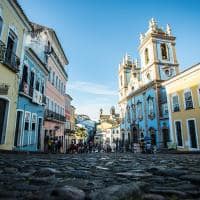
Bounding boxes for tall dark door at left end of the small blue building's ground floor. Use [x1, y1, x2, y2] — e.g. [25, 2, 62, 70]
[14, 111, 23, 147]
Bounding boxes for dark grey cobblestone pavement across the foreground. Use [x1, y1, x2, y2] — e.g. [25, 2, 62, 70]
[0, 153, 200, 200]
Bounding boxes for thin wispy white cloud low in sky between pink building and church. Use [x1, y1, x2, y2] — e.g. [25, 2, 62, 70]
[68, 81, 118, 96]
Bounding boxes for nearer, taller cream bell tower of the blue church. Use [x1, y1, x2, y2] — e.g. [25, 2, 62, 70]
[139, 18, 179, 83]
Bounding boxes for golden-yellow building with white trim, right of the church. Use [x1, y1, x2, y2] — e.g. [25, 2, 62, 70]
[164, 64, 200, 151]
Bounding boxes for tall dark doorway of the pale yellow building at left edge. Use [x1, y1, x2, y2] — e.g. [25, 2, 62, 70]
[0, 99, 8, 144]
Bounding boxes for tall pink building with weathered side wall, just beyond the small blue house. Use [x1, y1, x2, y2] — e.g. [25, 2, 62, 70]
[27, 23, 68, 152]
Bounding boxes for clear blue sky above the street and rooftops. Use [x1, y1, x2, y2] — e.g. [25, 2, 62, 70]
[19, 0, 200, 119]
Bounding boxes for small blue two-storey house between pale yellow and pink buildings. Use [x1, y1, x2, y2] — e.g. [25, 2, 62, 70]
[14, 48, 48, 151]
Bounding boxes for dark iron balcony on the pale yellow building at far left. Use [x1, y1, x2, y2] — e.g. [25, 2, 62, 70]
[0, 40, 20, 72]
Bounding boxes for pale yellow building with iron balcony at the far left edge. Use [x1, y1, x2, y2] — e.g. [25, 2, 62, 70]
[0, 0, 31, 150]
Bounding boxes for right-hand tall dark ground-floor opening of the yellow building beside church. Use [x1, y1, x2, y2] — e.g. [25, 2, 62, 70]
[188, 120, 197, 148]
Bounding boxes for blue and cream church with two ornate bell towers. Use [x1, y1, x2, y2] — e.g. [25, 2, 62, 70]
[119, 19, 179, 147]
